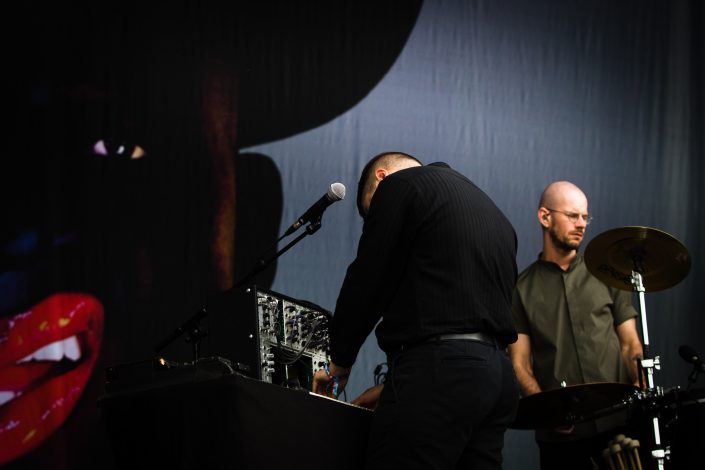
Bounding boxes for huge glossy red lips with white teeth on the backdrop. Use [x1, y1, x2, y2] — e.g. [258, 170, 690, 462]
[0, 293, 103, 465]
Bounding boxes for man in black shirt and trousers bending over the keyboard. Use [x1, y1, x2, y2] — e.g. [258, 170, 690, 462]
[314, 152, 519, 469]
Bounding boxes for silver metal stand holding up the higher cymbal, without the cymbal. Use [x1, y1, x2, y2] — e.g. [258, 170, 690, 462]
[631, 264, 671, 470]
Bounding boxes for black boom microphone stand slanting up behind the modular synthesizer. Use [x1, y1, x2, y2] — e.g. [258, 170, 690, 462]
[154, 216, 322, 362]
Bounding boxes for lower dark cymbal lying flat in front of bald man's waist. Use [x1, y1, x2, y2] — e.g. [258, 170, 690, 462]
[509, 382, 638, 429]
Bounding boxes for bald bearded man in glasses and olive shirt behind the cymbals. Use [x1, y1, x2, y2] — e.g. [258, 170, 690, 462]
[509, 181, 643, 470]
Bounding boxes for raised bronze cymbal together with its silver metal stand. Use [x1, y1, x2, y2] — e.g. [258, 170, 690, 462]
[585, 226, 691, 470]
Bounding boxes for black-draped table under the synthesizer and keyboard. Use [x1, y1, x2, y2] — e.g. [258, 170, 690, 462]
[98, 374, 373, 470]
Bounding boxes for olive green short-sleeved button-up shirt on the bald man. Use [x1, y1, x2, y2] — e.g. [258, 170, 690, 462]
[512, 254, 637, 437]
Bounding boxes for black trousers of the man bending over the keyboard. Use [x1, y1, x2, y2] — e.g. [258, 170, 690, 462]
[366, 340, 519, 470]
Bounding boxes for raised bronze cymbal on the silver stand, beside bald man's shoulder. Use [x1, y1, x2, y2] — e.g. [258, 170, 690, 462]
[585, 227, 690, 292]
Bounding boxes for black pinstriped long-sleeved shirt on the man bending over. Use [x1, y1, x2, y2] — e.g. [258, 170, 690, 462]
[330, 164, 517, 367]
